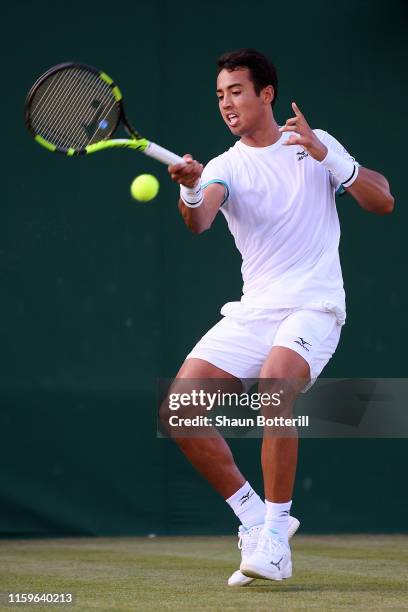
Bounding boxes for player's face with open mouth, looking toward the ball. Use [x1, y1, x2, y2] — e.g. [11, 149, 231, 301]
[217, 68, 270, 136]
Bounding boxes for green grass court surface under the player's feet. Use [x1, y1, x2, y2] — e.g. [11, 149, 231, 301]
[0, 535, 408, 612]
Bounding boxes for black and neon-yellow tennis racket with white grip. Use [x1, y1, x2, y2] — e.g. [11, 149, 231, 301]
[24, 62, 184, 165]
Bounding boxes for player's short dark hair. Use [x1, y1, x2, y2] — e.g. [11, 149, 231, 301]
[217, 49, 278, 107]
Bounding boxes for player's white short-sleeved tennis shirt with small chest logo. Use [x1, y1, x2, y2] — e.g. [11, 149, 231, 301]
[202, 130, 354, 324]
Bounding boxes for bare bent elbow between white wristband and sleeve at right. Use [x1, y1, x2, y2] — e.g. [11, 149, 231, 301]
[346, 167, 394, 215]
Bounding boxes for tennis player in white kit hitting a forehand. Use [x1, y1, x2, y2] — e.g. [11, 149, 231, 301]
[164, 49, 394, 586]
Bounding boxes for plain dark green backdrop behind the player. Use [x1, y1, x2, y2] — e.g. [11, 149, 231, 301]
[0, 0, 408, 536]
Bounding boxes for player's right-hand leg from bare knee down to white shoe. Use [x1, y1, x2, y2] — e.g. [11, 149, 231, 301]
[241, 347, 310, 580]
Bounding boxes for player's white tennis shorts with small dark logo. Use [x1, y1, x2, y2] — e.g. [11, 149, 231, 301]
[187, 302, 341, 381]
